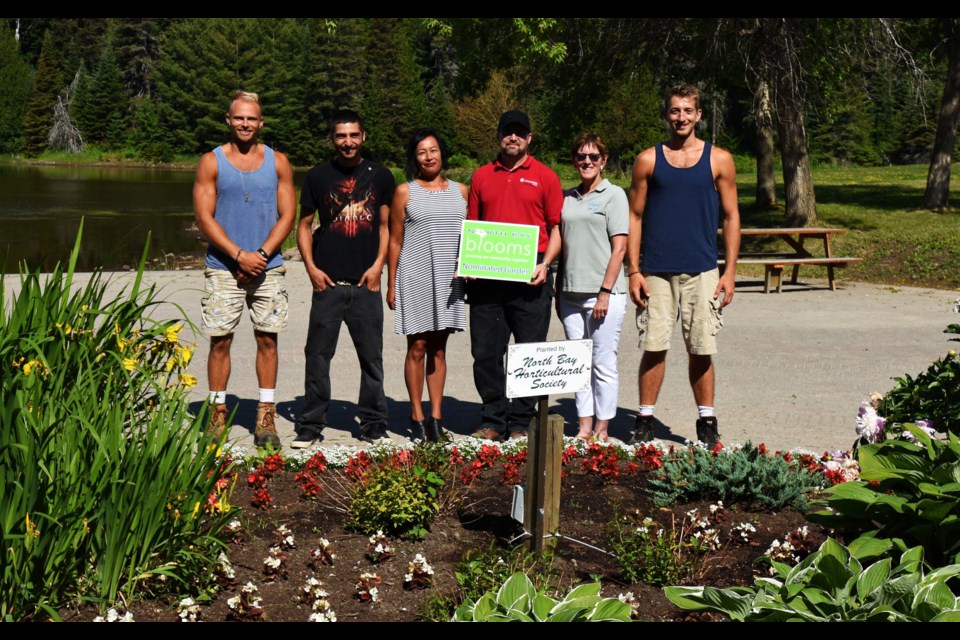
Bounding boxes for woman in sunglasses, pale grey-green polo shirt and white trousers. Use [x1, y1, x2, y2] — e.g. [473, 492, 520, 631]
[557, 133, 629, 441]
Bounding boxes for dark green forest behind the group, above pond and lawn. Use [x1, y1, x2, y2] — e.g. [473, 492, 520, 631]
[0, 18, 960, 224]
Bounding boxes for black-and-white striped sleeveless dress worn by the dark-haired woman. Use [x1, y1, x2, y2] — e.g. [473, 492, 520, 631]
[394, 180, 467, 335]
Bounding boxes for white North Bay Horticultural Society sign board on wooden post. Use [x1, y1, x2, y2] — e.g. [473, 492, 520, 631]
[507, 340, 593, 398]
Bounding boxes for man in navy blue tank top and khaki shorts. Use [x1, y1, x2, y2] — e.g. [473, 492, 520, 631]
[627, 84, 740, 446]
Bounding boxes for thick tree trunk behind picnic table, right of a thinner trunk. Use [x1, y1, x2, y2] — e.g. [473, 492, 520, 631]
[761, 18, 817, 227]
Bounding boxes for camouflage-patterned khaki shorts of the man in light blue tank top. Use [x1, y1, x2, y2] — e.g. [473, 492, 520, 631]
[200, 266, 289, 338]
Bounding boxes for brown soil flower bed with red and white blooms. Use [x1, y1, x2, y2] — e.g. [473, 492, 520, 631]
[64, 439, 848, 621]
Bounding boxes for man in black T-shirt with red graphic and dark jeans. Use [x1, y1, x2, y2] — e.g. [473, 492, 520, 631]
[292, 109, 395, 448]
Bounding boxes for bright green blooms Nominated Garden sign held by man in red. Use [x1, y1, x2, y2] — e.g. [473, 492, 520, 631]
[457, 220, 540, 282]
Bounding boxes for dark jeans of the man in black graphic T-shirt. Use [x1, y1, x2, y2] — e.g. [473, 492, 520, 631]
[300, 284, 387, 433]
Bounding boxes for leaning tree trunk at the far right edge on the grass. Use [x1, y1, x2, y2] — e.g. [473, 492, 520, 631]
[923, 18, 960, 211]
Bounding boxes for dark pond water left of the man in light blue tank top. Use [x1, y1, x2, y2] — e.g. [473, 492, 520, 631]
[0, 164, 204, 273]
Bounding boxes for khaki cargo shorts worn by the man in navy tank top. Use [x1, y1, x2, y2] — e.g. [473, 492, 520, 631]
[637, 269, 723, 356]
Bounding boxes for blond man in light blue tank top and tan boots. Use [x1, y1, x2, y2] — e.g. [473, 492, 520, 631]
[193, 91, 297, 449]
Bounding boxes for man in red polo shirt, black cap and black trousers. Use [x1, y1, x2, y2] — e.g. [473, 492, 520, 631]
[467, 111, 563, 440]
